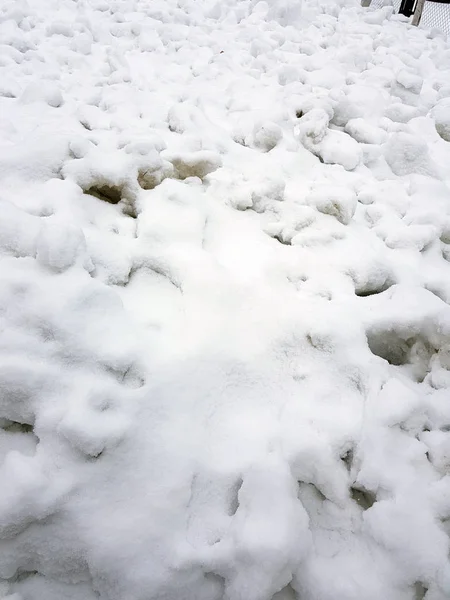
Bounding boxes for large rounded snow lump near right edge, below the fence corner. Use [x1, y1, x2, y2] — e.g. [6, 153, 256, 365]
[384, 133, 436, 177]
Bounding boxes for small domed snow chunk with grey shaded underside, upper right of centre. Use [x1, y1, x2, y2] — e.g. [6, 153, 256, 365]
[305, 185, 358, 225]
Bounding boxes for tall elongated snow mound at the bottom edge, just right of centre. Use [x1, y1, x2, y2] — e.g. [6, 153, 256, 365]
[212, 456, 311, 600]
